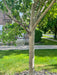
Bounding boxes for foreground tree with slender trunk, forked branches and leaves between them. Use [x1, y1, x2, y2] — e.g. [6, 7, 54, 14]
[0, 0, 56, 75]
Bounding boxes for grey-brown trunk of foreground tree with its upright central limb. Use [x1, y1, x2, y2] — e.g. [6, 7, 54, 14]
[29, 4, 35, 75]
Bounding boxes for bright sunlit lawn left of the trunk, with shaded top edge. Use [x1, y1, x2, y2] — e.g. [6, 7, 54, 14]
[0, 50, 29, 72]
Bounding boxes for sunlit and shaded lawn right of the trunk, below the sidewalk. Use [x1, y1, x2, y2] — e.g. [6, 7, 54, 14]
[35, 50, 57, 72]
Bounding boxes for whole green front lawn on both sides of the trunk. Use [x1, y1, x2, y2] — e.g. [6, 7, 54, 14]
[0, 49, 57, 75]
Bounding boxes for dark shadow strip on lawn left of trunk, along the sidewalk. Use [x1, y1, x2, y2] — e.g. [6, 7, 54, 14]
[0, 50, 29, 58]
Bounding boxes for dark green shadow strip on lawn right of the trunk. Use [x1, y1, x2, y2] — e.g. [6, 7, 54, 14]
[35, 49, 57, 57]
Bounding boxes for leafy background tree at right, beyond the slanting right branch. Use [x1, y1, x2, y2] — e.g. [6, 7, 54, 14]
[38, 3, 57, 38]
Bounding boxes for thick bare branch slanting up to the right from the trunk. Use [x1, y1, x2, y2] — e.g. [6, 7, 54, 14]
[32, 0, 56, 31]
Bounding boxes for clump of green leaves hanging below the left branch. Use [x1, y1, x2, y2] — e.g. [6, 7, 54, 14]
[2, 23, 25, 43]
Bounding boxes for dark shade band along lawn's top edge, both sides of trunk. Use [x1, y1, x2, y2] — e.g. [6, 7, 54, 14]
[0, 49, 57, 58]
